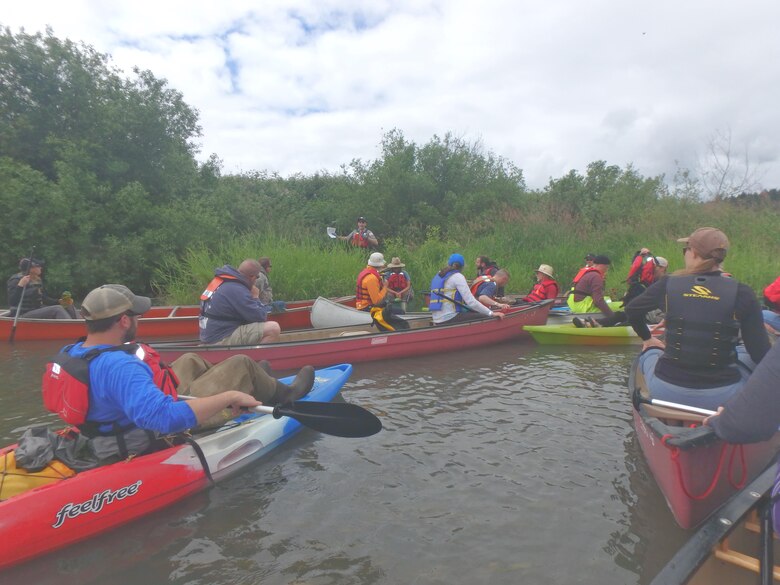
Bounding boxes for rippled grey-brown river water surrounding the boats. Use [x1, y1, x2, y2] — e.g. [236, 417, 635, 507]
[0, 341, 690, 585]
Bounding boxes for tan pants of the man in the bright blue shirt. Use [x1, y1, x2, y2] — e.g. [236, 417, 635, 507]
[171, 353, 276, 429]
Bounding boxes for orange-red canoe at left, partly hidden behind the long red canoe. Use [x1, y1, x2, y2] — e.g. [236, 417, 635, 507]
[0, 296, 355, 341]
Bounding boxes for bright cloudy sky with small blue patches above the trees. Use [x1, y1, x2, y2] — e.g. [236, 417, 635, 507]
[0, 0, 780, 188]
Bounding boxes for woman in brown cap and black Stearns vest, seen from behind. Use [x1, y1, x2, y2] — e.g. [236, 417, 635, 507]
[625, 227, 769, 410]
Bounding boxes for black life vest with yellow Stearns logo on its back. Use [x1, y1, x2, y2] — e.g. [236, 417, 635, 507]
[664, 274, 739, 367]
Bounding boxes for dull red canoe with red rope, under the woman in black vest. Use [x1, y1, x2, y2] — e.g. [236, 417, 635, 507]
[629, 362, 780, 529]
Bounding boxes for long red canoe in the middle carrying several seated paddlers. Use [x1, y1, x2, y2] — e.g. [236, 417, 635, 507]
[153, 301, 551, 370]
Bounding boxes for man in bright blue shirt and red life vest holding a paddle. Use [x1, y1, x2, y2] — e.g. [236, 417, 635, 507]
[42, 284, 314, 464]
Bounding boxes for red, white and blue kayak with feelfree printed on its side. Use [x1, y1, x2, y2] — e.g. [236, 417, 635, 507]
[0, 364, 353, 570]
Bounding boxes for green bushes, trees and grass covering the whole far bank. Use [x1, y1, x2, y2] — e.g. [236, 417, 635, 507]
[0, 28, 780, 304]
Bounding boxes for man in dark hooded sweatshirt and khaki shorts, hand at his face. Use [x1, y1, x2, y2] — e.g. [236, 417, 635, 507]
[198, 259, 281, 345]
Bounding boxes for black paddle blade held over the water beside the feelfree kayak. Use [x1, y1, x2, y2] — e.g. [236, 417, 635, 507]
[274, 401, 382, 437]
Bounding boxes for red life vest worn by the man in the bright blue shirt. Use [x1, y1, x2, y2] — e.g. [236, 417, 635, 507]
[42, 344, 179, 425]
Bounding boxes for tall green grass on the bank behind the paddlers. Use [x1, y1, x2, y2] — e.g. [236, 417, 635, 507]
[155, 200, 780, 308]
